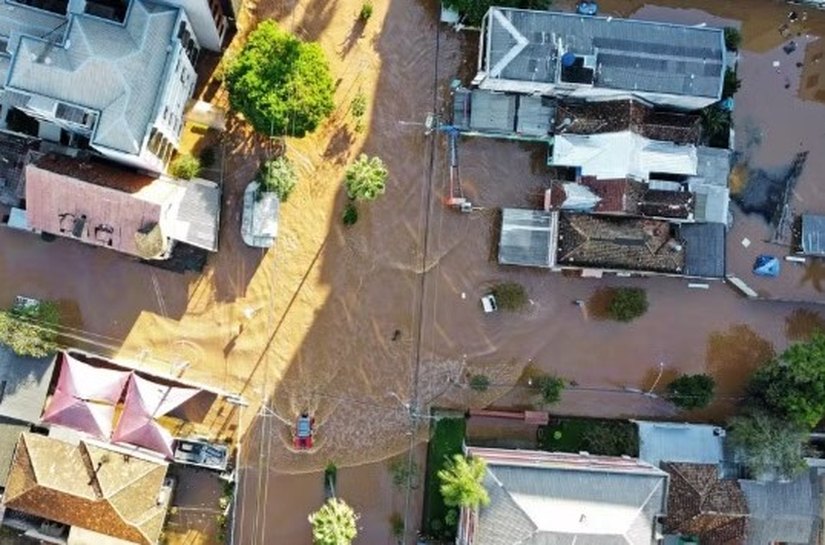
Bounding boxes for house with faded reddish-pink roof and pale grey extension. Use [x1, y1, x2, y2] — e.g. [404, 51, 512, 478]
[25, 154, 220, 259]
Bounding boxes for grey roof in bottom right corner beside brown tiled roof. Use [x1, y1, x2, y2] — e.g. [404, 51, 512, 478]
[739, 468, 822, 545]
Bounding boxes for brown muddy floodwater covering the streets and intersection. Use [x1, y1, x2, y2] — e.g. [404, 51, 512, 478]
[0, 0, 825, 545]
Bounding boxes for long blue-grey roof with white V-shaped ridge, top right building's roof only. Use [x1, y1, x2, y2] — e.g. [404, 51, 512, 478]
[487, 8, 725, 98]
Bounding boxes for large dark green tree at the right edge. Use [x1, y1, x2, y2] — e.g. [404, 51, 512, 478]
[749, 334, 825, 428]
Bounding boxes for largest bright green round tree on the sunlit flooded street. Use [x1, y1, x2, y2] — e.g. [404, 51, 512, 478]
[225, 20, 334, 136]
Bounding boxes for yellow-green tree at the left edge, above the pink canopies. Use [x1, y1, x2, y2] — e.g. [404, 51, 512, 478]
[0, 301, 60, 358]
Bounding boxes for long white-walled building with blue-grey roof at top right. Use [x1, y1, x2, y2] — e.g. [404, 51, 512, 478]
[473, 7, 726, 110]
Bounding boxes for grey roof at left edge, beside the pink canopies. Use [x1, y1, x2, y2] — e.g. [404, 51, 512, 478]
[0, 347, 54, 424]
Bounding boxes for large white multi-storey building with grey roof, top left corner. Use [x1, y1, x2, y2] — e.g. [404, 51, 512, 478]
[0, 0, 227, 173]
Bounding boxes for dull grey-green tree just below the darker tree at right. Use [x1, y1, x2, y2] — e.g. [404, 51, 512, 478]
[729, 411, 807, 478]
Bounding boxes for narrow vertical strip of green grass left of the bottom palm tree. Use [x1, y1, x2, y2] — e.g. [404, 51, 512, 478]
[422, 418, 467, 539]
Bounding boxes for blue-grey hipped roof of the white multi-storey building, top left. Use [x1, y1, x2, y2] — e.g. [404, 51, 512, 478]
[8, 0, 179, 154]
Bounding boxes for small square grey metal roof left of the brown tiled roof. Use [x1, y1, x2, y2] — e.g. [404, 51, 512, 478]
[498, 208, 558, 268]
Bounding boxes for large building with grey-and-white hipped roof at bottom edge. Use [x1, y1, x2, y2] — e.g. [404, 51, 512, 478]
[456, 447, 668, 545]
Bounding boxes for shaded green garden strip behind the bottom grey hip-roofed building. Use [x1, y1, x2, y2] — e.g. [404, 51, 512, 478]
[538, 418, 639, 456]
